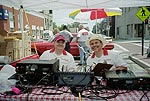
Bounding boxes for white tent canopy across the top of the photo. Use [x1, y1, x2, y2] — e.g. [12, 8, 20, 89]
[0, 0, 150, 11]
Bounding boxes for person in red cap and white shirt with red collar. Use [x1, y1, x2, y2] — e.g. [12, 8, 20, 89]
[40, 34, 76, 71]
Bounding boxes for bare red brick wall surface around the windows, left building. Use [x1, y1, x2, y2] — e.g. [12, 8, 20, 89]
[0, 5, 44, 36]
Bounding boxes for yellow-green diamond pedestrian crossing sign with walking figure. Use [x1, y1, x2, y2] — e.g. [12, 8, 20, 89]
[136, 7, 150, 21]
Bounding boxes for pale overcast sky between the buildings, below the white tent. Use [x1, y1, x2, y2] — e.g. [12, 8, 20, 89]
[53, 9, 103, 30]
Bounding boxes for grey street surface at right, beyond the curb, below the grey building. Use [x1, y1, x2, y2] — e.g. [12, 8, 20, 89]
[114, 40, 150, 64]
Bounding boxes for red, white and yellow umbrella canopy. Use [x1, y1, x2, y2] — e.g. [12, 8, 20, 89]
[69, 8, 122, 20]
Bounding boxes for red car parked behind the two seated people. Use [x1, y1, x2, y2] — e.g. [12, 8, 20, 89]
[31, 33, 114, 57]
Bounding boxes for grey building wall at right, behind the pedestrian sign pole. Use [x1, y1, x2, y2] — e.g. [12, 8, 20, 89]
[115, 7, 149, 39]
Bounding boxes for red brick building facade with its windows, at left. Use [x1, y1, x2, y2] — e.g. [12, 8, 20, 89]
[0, 5, 44, 37]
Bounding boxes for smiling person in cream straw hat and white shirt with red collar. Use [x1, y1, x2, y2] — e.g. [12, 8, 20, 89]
[85, 34, 127, 70]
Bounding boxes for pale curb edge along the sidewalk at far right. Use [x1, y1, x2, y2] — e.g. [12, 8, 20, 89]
[129, 56, 150, 68]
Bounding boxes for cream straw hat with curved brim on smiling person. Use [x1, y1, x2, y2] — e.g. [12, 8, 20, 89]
[85, 34, 106, 48]
